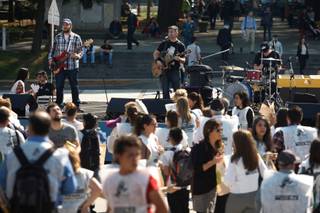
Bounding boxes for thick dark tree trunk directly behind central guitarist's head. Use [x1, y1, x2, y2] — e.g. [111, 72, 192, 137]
[158, 0, 182, 32]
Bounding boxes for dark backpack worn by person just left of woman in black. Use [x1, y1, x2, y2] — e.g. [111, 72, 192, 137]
[171, 148, 193, 186]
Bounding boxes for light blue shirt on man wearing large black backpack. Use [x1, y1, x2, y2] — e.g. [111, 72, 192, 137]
[0, 136, 77, 204]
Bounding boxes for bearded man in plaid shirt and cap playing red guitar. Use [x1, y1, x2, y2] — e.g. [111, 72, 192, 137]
[48, 18, 82, 111]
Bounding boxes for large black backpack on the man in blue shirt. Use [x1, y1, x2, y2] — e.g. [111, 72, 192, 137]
[10, 146, 55, 213]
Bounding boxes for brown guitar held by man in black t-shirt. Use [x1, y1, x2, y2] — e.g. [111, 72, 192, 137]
[152, 49, 191, 78]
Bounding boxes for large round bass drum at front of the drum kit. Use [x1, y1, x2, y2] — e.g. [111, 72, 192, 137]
[224, 81, 253, 107]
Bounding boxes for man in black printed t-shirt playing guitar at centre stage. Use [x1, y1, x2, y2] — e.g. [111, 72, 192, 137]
[153, 26, 185, 99]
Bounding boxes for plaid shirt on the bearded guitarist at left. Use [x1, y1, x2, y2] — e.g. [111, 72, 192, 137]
[48, 32, 82, 70]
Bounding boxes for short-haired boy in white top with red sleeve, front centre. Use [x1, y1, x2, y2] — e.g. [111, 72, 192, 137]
[102, 136, 168, 213]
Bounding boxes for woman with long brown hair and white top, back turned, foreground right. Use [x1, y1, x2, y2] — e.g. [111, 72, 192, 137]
[224, 130, 267, 213]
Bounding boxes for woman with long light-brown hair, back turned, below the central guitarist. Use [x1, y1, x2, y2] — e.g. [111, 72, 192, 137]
[177, 98, 199, 147]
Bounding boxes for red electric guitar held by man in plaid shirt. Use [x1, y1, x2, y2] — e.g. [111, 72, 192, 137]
[50, 38, 93, 75]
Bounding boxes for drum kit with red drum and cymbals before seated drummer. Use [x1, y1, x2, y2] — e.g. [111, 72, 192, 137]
[220, 58, 282, 110]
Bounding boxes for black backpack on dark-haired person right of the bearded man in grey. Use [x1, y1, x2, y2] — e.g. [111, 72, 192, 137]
[80, 129, 100, 171]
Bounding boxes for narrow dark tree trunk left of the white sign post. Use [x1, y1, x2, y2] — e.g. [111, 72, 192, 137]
[31, 0, 45, 54]
